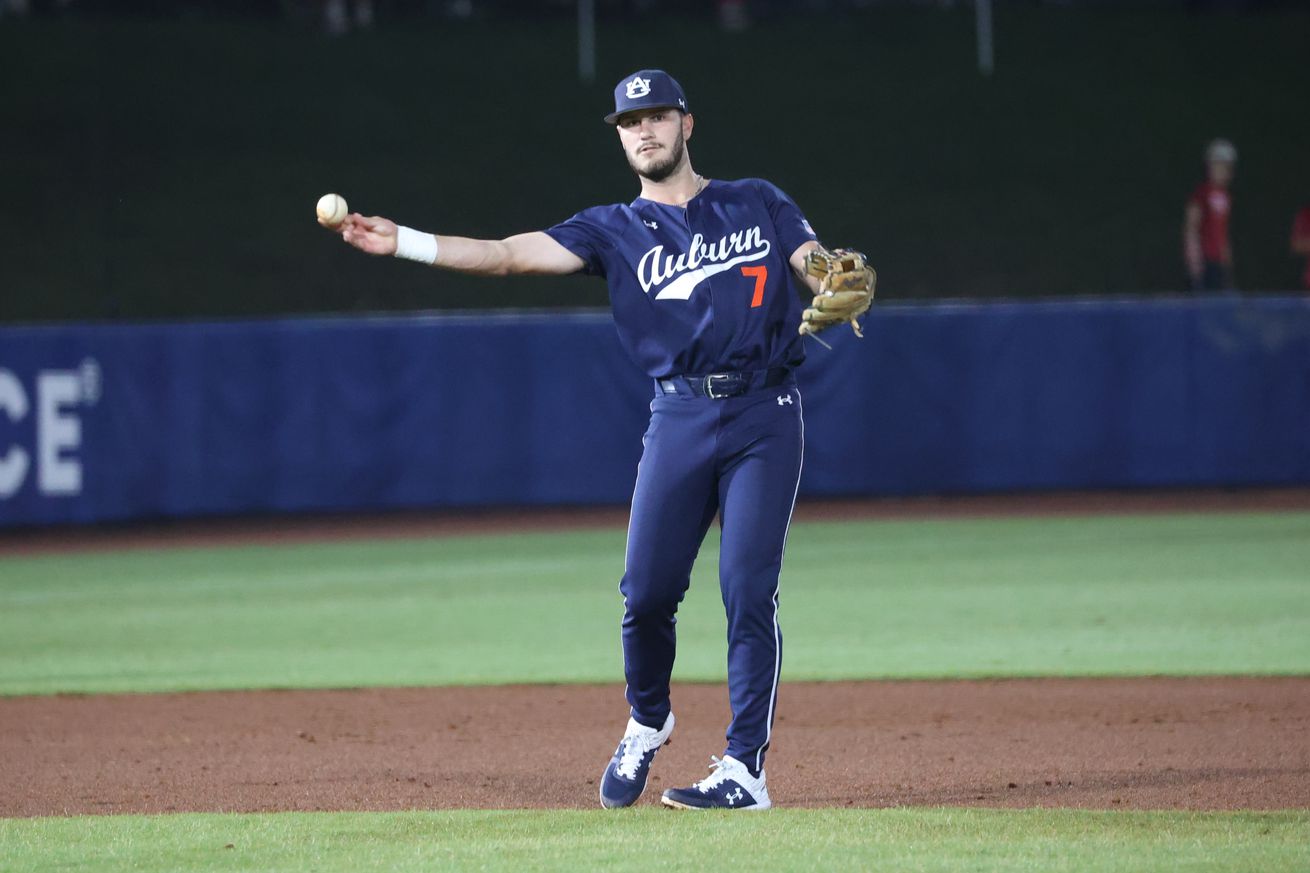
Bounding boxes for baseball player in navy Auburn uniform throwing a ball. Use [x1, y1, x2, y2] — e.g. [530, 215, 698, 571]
[319, 69, 874, 810]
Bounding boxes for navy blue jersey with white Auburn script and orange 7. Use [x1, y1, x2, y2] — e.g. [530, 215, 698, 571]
[546, 178, 815, 379]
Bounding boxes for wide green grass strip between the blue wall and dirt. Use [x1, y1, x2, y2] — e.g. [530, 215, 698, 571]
[0, 513, 1310, 695]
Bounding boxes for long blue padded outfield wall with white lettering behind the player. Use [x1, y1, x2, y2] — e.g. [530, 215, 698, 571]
[0, 296, 1310, 527]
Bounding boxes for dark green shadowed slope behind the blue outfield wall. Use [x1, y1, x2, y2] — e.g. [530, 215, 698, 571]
[0, 5, 1310, 322]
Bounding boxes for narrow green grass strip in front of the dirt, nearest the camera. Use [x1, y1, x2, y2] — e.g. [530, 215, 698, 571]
[0, 807, 1310, 873]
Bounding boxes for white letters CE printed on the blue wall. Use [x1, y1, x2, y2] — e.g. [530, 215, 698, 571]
[0, 358, 102, 499]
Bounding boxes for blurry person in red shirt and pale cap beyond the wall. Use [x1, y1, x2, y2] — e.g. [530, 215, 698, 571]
[1183, 139, 1237, 291]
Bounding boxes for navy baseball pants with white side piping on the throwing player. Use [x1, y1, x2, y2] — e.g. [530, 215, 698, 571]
[618, 379, 804, 773]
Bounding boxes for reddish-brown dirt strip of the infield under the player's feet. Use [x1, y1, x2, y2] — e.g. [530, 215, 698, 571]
[0, 678, 1310, 817]
